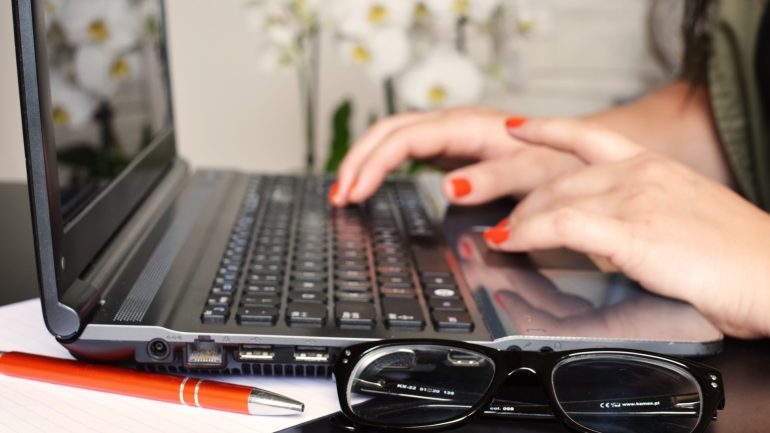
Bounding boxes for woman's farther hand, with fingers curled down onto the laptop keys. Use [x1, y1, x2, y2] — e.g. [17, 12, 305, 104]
[330, 107, 582, 206]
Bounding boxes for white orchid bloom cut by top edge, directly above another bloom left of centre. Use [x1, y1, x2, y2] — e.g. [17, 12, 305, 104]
[332, 0, 415, 37]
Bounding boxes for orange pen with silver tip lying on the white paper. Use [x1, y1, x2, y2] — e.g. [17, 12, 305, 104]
[0, 352, 305, 415]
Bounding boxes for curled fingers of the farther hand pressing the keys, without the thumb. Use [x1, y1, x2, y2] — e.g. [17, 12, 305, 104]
[337, 108, 520, 204]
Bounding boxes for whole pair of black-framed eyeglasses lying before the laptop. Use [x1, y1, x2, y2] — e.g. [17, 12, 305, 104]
[334, 340, 724, 433]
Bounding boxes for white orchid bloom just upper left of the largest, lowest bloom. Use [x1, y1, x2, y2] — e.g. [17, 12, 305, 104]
[340, 28, 411, 81]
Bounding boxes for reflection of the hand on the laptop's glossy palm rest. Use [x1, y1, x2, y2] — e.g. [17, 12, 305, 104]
[455, 231, 722, 354]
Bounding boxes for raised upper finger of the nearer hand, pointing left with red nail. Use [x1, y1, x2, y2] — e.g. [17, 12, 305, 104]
[506, 117, 644, 164]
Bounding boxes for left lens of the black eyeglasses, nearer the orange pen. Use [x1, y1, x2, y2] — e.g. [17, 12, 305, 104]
[347, 345, 495, 427]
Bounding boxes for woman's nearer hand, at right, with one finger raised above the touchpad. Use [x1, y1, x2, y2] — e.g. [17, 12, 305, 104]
[485, 119, 770, 338]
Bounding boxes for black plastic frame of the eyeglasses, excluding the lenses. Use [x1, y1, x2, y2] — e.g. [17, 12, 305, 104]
[333, 339, 725, 433]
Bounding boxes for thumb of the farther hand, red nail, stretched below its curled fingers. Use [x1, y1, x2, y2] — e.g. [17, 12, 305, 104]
[443, 147, 582, 205]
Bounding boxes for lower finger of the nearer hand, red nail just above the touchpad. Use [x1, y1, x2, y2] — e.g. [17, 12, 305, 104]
[484, 207, 639, 271]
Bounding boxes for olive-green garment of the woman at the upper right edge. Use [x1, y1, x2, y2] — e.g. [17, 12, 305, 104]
[708, 0, 770, 210]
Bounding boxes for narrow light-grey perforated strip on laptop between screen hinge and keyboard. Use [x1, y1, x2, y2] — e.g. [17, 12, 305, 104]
[113, 183, 211, 322]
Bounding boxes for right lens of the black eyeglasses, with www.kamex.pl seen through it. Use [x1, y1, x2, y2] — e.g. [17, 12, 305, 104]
[553, 354, 702, 433]
